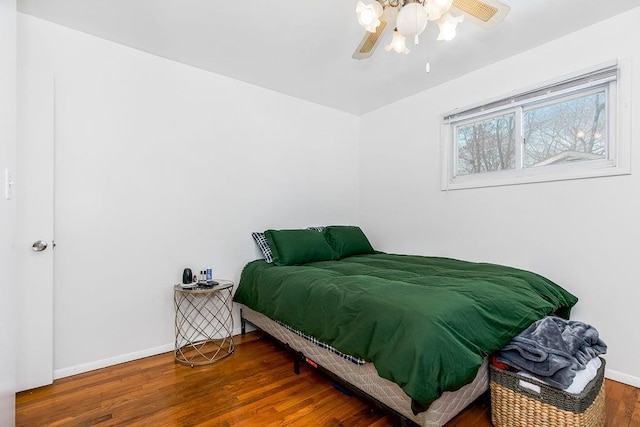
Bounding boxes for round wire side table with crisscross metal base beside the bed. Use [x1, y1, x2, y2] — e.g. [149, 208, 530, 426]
[173, 280, 234, 368]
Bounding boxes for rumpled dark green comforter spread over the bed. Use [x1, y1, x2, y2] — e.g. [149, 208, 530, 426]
[234, 253, 577, 407]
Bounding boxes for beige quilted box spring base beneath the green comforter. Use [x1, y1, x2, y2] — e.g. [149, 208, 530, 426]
[240, 306, 489, 427]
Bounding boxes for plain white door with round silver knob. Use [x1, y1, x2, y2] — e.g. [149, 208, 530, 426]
[15, 69, 54, 391]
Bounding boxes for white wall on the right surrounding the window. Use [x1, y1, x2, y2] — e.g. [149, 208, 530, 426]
[359, 8, 640, 386]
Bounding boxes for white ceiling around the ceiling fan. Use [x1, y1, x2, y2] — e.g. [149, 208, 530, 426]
[17, 0, 640, 114]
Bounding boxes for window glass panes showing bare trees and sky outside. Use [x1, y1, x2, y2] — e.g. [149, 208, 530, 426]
[456, 89, 607, 176]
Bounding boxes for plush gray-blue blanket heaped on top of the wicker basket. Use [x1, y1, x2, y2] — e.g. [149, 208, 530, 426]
[496, 316, 607, 389]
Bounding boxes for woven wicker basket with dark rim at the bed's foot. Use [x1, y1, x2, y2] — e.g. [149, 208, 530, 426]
[490, 358, 605, 427]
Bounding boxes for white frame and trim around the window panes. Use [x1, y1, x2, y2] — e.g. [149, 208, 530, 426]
[441, 59, 631, 191]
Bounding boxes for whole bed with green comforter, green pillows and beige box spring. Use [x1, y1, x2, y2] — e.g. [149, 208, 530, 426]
[234, 226, 577, 426]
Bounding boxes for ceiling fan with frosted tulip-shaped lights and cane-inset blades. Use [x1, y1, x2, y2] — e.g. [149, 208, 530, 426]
[353, 0, 511, 59]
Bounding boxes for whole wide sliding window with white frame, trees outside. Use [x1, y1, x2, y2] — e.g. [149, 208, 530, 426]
[442, 62, 630, 190]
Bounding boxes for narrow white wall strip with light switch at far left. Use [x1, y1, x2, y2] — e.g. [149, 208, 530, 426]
[0, 0, 17, 426]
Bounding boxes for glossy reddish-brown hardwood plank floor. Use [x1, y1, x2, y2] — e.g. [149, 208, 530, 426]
[16, 332, 640, 427]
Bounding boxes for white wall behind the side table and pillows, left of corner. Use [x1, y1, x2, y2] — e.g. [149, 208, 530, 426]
[18, 14, 359, 377]
